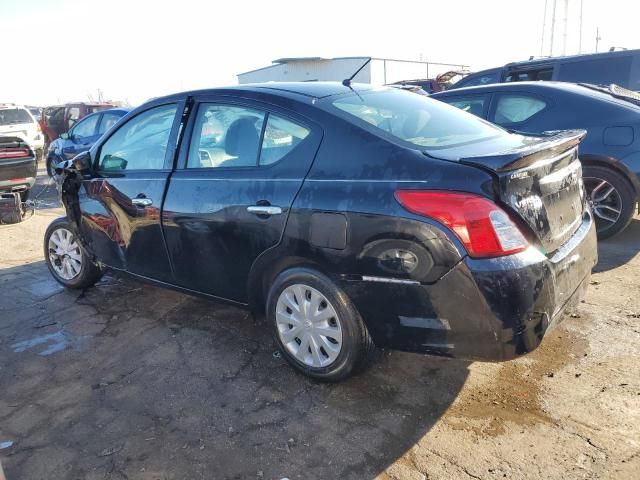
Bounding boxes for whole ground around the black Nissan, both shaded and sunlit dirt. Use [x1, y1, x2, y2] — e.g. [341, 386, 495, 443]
[0, 167, 640, 480]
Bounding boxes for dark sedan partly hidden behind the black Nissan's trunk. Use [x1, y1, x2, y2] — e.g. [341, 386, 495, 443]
[433, 82, 640, 238]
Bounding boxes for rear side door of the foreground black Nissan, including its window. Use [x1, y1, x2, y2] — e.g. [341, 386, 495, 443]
[162, 97, 322, 302]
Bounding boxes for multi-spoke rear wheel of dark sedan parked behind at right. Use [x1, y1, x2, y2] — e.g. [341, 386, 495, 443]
[582, 165, 637, 240]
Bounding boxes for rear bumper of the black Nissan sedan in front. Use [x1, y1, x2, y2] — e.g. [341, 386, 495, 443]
[342, 210, 597, 361]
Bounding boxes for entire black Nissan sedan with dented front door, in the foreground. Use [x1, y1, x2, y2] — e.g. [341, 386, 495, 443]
[44, 82, 596, 380]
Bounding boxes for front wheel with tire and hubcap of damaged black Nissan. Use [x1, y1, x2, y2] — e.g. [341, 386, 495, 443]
[44, 217, 103, 289]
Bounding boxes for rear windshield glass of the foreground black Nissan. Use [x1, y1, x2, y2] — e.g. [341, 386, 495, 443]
[332, 89, 508, 150]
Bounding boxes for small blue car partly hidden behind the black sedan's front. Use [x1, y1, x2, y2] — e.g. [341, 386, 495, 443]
[47, 108, 129, 176]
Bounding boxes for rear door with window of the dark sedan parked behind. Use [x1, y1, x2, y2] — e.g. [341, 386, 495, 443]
[488, 91, 553, 133]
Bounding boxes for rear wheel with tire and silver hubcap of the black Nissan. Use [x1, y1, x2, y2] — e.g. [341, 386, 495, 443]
[266, 268, 376, 382]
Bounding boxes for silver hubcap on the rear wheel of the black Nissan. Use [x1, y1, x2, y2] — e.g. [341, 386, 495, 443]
[276, 284, 342, 367]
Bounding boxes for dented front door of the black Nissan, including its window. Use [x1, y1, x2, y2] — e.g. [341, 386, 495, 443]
[80, 101, 184, 282]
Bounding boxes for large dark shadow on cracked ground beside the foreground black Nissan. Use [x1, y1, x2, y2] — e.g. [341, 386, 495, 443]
[0, 262, 468, 480]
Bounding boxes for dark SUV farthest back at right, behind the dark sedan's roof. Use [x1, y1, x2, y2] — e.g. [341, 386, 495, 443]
[450, 50, 640, 91]
